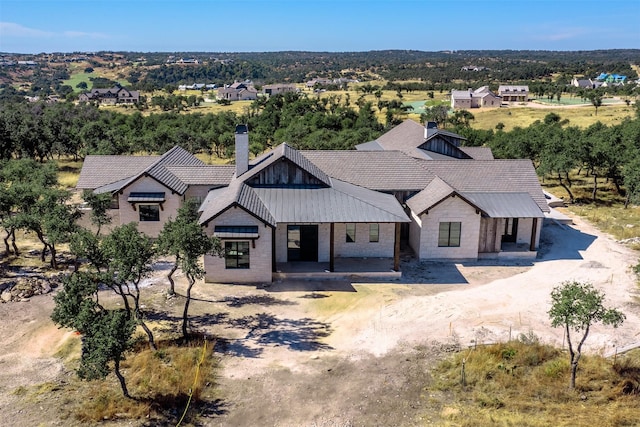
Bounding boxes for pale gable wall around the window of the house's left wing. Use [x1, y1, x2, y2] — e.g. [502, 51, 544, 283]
[118, 177, 183, 238]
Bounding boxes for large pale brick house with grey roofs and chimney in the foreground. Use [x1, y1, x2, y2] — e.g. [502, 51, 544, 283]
[78, 120, 549, 283]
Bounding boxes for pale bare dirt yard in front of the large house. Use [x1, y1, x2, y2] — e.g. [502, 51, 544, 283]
[0, 212, 640, 427]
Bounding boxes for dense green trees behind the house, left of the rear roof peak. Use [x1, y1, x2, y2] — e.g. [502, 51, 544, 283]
[0, 93, 383, 161]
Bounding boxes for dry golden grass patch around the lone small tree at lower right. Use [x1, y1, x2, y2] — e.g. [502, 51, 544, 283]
[434, 341, 640, 427]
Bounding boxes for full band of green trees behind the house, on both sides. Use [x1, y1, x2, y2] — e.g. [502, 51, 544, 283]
[0, 90, 640, 203]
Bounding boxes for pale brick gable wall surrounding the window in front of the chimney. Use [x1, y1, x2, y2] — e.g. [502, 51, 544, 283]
[204, 207, 272, 283]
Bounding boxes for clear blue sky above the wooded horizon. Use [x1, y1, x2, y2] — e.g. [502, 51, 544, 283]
[0, 0, 640, 53]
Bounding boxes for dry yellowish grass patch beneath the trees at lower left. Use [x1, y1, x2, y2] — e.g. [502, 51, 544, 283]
[72, 341, 217, 424]
